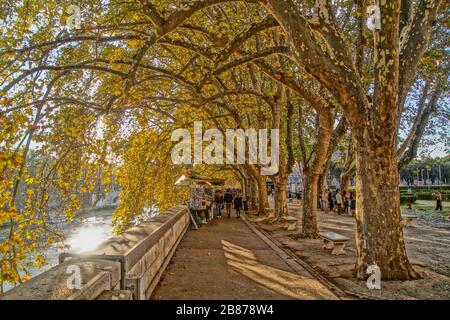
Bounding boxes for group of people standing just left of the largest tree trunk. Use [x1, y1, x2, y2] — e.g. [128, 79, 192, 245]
[319, 188, 354, 215]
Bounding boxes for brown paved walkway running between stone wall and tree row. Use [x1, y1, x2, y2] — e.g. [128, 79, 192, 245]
[152, 210, 336, 300]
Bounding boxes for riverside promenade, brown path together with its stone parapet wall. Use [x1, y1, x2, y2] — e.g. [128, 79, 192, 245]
[0, 206, 341, 300]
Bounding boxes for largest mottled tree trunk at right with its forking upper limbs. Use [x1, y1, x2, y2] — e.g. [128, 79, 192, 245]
[263, 0, 440, 280]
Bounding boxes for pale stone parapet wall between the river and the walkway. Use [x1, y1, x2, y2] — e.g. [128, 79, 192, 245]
[0, 206, 190, 300]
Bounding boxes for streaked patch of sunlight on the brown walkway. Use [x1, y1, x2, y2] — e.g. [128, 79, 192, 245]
[222, 240, 335, 299]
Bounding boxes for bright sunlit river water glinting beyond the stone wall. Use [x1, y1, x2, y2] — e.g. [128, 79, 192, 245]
[0, 208, 115, 292]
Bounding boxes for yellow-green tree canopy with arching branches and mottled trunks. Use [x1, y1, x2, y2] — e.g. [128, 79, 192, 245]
[0, 0, 450, 290]
